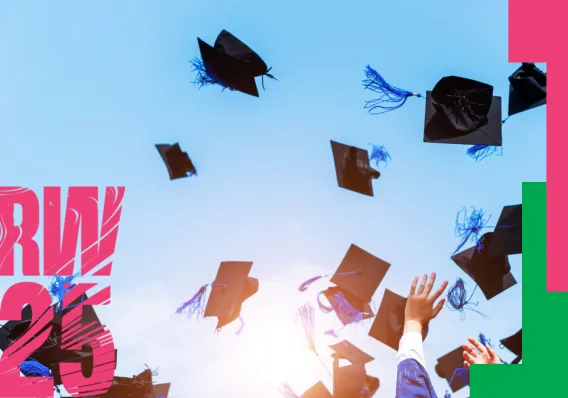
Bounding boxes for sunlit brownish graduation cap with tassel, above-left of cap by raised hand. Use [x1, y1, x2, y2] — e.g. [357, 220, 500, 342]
[300, 244, 390, 325]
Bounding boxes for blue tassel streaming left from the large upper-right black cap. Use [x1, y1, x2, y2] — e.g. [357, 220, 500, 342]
[363, 65, 422, 114]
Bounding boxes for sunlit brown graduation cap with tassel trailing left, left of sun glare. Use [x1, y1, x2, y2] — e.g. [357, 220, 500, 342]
[176, 261, 258, 330]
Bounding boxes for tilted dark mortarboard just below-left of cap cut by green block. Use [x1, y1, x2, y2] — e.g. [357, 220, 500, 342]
[452, 232, 517, 300]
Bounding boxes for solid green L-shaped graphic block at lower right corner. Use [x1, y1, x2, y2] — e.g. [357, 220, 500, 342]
[470, 182, 568, 398]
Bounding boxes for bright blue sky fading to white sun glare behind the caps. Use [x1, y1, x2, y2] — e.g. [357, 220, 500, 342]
[0, 0, 545, 398]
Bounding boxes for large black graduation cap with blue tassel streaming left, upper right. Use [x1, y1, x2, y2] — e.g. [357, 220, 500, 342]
[363, 66, 502, 146]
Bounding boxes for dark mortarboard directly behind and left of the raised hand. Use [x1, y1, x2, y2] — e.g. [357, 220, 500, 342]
[369, 289, 428, 351]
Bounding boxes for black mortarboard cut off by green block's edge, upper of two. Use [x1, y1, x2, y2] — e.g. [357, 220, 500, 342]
[489, 205, 523, 256]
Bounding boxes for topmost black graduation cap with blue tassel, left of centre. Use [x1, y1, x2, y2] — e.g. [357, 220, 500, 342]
[191, 30, 275, 97]
